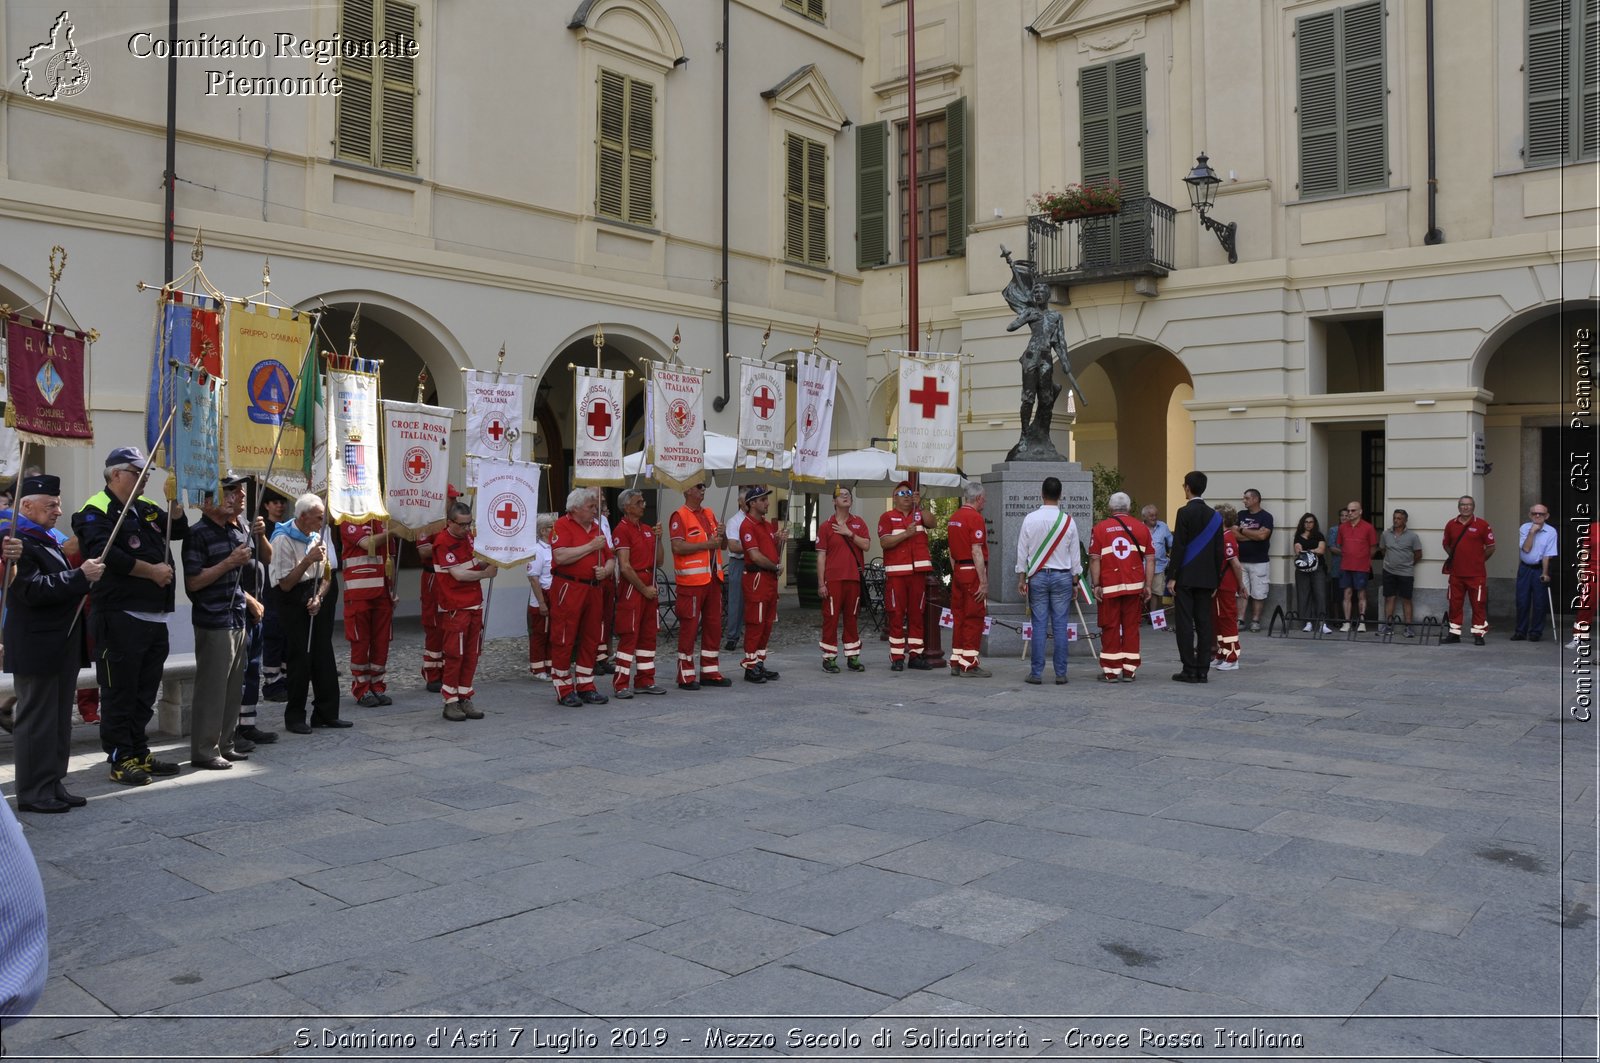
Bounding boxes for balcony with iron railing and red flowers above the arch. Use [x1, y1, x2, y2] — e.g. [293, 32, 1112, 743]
[1027, 195, 1178, 283]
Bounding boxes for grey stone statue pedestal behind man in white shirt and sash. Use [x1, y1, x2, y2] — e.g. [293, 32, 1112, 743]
[981, 461, 1094, 659]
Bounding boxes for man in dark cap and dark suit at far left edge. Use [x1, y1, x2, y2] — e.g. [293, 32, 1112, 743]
[5, 475, 106, 813]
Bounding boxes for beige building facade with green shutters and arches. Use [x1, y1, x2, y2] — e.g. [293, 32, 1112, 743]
[0, 0, 1600, 624]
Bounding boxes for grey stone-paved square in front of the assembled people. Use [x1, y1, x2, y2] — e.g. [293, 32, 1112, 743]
[0, 610, 1600, 1060]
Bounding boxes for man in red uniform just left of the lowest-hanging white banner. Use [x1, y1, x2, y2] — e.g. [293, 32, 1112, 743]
[429, 503, 499, 722]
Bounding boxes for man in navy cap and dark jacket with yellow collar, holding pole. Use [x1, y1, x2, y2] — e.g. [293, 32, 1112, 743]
[72, 447, 189, 786]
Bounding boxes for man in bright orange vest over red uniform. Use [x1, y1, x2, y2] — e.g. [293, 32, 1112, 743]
[667, 482, 732, 690]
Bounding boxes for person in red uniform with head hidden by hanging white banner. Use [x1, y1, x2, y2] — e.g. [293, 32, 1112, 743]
[339, 520, 398, 709]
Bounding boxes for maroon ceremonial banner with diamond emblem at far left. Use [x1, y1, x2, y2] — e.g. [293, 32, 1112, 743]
[5, 315, 94, 447]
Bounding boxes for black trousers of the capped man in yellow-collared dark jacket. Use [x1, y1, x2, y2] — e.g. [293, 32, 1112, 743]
[90, 608, 170, 764]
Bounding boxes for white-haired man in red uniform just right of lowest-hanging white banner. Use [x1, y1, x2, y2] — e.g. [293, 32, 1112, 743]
[550, 487, 616, 709]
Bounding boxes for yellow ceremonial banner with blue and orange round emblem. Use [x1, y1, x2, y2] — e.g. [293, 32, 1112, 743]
[222, 303, 315, 480]
